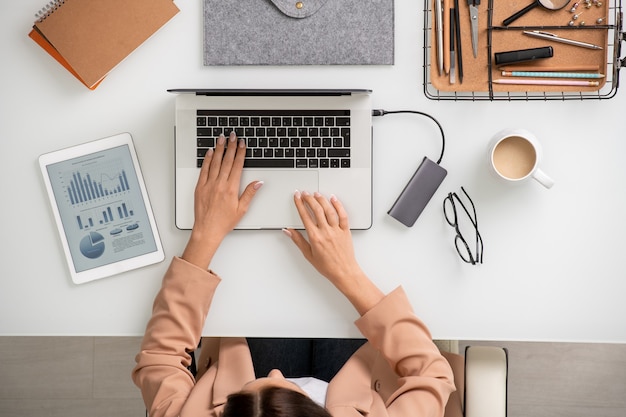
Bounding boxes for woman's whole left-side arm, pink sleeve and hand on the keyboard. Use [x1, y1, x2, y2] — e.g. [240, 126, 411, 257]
[132, 134, 262, 416]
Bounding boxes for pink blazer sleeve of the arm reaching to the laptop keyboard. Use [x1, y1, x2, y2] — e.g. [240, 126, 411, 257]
[132, 258, 220, 417]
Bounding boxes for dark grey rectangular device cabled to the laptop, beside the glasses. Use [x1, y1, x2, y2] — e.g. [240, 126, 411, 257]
[388, 157, 448, 227]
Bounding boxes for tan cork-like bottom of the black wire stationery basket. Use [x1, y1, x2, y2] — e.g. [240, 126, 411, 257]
[430, 0, 609, 92]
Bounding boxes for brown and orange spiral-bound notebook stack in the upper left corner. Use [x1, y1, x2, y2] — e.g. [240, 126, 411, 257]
[28, 0, 179, 90]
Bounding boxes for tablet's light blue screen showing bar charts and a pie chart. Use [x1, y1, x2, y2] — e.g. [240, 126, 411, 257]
[40, 133, 161, 282]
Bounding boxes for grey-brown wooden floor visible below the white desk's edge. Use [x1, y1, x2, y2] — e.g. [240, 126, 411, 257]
[0, 337, 626, 417]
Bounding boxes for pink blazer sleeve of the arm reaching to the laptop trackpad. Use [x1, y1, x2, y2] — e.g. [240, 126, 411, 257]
[356, 287, 455, 417]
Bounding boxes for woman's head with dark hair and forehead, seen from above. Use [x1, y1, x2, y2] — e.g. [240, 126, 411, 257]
[223, 371, 331, 417]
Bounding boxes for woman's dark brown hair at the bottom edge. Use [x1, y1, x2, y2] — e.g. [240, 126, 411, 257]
[222, 387, 331, 417]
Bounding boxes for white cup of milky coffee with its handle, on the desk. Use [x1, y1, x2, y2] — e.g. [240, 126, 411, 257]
[489, 129, 554, 188]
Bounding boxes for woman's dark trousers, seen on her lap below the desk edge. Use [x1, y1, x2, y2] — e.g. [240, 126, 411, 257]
[247, 337, 366, 382]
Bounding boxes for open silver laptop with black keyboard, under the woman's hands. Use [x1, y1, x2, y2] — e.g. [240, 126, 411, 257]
[168, 89, 372, 229]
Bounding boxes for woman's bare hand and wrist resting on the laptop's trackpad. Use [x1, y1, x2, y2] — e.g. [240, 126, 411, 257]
[285, 192, 383, 314]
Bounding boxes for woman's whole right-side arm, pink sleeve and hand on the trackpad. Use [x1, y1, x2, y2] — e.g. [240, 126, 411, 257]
[285, 192, 455, 417]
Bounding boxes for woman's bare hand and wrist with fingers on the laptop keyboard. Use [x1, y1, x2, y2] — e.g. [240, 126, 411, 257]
[182, 132, 263, 268]
